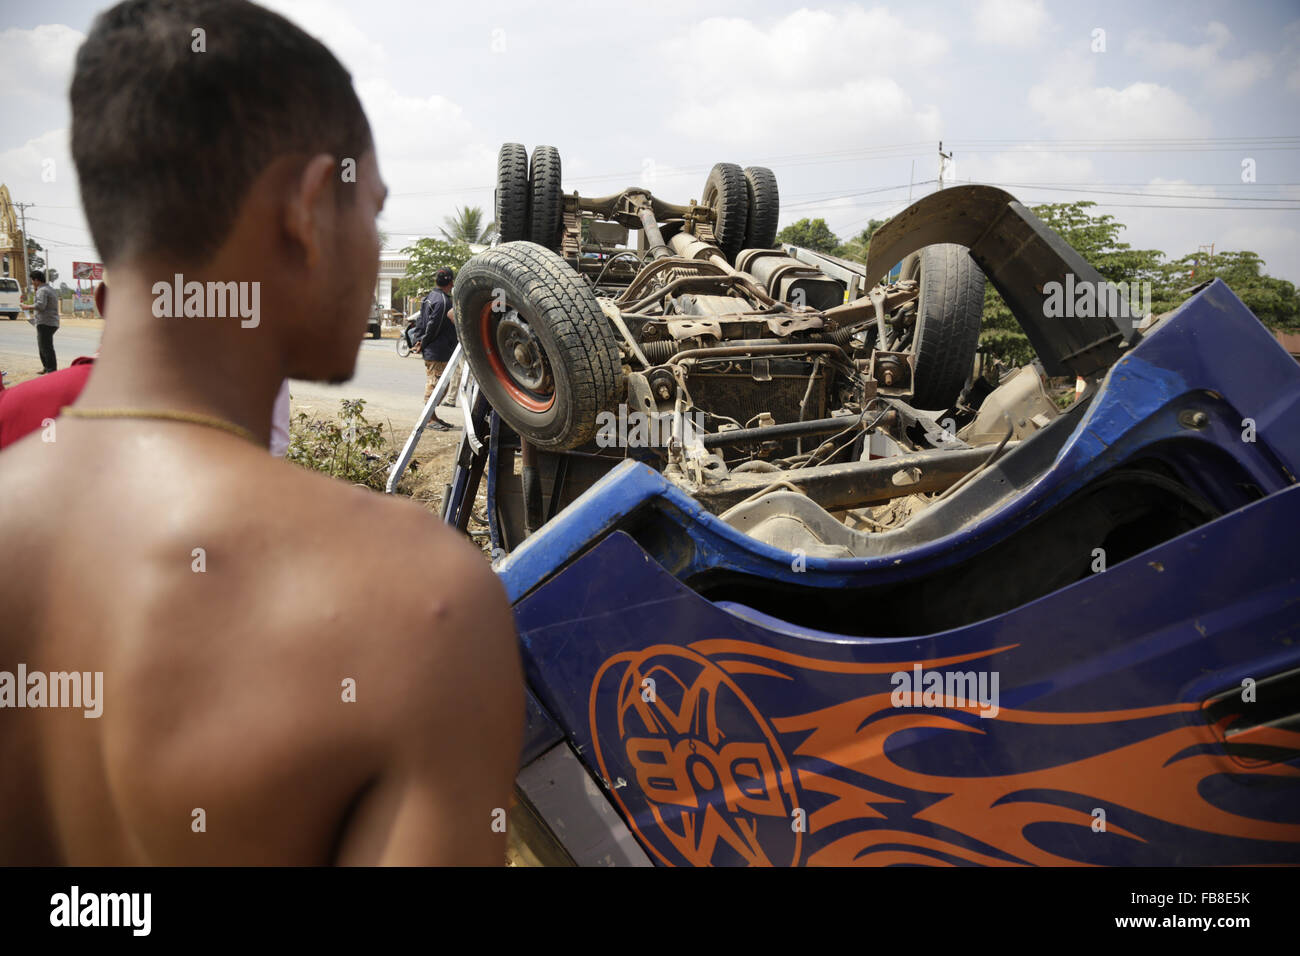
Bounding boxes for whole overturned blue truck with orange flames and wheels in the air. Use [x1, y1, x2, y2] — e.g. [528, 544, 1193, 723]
[445, 146, 1300, 865]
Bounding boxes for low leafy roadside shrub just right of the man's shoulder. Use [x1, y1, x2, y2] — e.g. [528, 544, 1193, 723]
[285, 398, 397, 490]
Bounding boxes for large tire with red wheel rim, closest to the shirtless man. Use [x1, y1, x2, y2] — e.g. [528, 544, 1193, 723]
[454, 242, 621, 449]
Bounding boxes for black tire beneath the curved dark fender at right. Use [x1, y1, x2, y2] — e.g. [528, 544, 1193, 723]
[901, 243, 984, 411]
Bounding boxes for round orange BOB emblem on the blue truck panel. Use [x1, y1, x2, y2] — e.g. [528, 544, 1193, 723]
[592, 645, 802, 866]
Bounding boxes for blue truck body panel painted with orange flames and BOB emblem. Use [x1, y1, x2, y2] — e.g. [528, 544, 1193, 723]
[499, 282, 1300, 865]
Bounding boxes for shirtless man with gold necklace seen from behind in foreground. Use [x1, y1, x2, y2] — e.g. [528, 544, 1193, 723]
[0, 0, 523, 865]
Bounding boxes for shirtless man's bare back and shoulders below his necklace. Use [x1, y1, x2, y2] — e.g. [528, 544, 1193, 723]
[0, 419, 521, 865]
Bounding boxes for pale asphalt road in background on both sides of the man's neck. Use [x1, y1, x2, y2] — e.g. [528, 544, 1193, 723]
[0, 319, 460, 432]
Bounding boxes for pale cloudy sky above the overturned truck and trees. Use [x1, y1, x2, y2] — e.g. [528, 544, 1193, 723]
[0, 0, 1300, 284]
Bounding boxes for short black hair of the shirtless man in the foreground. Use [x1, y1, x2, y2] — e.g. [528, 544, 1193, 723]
[72, 0, 372, 265]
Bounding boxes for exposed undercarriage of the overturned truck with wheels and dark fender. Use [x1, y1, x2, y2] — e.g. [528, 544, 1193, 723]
[455, 144, 1134, 554]
